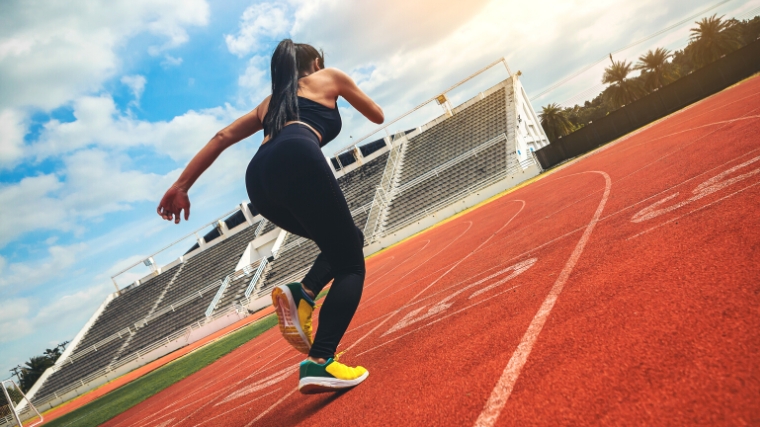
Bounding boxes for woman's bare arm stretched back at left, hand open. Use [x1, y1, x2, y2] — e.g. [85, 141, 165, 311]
[156, 98, 269, 224]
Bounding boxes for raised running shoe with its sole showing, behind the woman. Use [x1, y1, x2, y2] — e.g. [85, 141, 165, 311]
[272, 283, 314, 354]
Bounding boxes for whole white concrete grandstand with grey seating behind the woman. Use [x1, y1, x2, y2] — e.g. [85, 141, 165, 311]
[17, 61, 548, 424]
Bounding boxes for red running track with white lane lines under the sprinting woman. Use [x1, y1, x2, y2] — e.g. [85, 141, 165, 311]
[101, 78, 760, 427]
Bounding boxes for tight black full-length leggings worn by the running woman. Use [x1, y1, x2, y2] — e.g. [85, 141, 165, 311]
[245, 124, 365, 359]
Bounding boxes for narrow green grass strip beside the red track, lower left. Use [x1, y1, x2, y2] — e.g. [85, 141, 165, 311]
[45, 315, 277, 427]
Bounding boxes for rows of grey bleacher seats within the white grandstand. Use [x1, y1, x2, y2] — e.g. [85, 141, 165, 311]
[35, 74, 548, 412]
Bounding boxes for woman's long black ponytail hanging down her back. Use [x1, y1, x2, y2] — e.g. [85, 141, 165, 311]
[264, 39, 298, 138]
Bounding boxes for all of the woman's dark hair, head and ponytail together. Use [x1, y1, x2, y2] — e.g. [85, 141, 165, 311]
[264, 39, 325, 138]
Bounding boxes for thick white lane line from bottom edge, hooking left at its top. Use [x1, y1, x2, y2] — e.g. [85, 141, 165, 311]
[475, 171, 612, 427]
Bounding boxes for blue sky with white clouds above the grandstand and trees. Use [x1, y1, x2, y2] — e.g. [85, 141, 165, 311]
[0, 0, 760, 378]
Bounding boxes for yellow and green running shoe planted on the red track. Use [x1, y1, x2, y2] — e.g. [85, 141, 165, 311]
[298, 357, 369, 394]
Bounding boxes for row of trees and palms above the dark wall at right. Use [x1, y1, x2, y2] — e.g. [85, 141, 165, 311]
[539, 15, 760, 142]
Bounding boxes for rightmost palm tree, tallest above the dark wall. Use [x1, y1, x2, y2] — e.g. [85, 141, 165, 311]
[689, 14, 742, 67]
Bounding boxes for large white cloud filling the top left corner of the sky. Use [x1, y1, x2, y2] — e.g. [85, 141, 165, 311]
[0, 0, 209, 110]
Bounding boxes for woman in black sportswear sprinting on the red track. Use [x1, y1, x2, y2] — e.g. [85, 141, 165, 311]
[158, 39, 384, 393]
